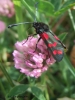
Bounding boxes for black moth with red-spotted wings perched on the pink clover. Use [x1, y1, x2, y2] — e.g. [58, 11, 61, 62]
[8, 22, 66, 62]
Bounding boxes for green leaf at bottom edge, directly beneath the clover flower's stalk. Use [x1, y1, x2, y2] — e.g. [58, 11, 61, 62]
[31, 86, 46, 100]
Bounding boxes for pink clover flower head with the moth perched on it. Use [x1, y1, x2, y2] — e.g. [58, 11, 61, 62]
[13, 37, 55, 78]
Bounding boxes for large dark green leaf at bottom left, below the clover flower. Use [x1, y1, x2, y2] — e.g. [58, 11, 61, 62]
[7, 84, 29, 98]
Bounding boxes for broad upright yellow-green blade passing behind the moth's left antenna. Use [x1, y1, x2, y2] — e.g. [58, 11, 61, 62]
[13, 0, 24, 40]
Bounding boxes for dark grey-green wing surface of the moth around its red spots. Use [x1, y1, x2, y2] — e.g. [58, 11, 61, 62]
[44, 31, 64, 62]
